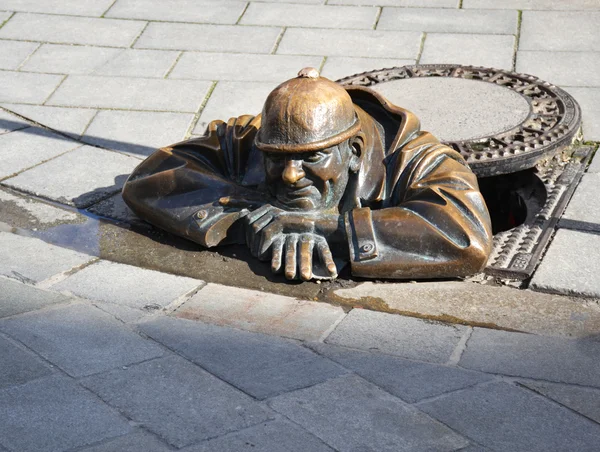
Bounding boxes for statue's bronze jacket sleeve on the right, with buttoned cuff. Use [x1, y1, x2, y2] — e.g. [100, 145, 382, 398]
[345, 134, 492, 279]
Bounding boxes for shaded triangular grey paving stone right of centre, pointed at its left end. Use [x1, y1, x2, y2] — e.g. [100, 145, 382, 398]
[309, 343, 492, 403]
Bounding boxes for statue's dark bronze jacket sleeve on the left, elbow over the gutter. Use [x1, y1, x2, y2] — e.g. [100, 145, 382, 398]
[123, 116, 262, 247]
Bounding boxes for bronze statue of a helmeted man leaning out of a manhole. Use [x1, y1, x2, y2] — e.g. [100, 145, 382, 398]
[123, 68, 492, 280]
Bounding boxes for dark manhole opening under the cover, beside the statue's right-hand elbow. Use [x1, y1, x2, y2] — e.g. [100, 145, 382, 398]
[479, 169, 547, 235]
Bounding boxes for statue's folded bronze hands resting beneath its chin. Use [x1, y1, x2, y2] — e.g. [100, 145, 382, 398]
[245, 205, 337, 281]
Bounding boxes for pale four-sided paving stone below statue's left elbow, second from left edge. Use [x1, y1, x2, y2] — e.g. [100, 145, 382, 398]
[52, 260, 203, 310]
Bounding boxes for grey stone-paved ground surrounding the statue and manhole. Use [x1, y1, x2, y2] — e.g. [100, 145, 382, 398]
[0, 0, 600, 452]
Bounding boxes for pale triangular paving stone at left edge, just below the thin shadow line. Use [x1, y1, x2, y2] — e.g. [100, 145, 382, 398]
[0, 126, 81, 179]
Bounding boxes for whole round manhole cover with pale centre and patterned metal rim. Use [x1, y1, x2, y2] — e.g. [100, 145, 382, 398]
[338, 65, 581, 177]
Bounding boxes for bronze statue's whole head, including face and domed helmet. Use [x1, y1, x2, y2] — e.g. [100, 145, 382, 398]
[255, 68, 365, 211]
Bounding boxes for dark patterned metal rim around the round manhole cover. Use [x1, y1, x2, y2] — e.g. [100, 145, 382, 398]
[337, 64, 581, 177]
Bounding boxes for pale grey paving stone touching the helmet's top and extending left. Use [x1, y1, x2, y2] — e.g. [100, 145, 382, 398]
[169, 52, 322, 83]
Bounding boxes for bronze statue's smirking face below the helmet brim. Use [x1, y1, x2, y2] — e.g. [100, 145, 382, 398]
[264, 141, 353, 211]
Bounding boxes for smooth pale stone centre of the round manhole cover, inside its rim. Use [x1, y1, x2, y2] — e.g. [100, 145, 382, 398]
[373, 77, 531, 141]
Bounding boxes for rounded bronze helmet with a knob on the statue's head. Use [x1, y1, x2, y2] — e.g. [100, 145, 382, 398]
[255, 68, 360, 152]
